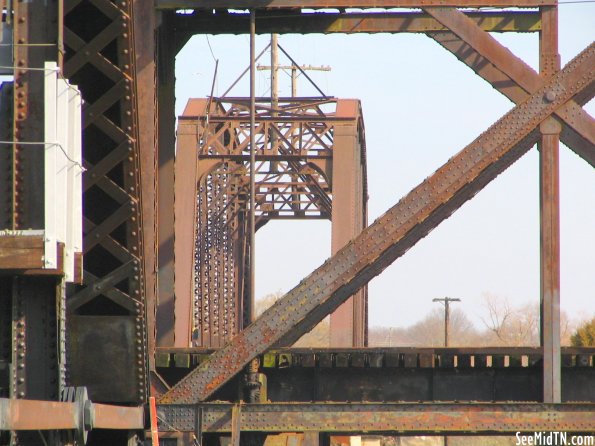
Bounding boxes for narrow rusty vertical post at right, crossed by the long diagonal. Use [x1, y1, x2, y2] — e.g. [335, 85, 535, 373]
[538, 6, 562, 403]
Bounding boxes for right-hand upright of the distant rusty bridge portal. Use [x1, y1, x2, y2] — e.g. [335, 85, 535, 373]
[330, 101, 366, 347]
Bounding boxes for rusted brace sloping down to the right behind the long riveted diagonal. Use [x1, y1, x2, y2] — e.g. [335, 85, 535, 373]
[426, 7, 595, 167]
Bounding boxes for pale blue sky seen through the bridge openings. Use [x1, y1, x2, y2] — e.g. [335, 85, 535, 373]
[176, 3, 595, 326]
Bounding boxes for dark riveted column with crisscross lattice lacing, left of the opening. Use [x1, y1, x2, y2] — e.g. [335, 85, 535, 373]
[63, 0, 148, 403]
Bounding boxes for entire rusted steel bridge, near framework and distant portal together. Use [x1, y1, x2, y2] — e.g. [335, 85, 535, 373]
[0, 0, 595, 445]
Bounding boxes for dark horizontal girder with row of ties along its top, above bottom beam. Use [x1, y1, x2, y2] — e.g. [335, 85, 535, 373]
[156, 347, 595, 403]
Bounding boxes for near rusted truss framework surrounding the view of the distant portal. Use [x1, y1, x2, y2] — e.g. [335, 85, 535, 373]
[0, 0, 595, 444]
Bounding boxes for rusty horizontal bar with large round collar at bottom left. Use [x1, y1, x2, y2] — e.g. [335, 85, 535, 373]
[0, 398, 144, 431]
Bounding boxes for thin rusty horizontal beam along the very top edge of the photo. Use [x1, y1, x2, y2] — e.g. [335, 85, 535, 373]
[155, 0, 558, 9]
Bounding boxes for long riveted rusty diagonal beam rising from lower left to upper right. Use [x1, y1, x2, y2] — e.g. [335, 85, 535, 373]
[160, 44, 595, 403]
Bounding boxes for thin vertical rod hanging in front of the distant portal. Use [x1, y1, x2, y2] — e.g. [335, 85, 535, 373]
[246, 9, 256, 322]
